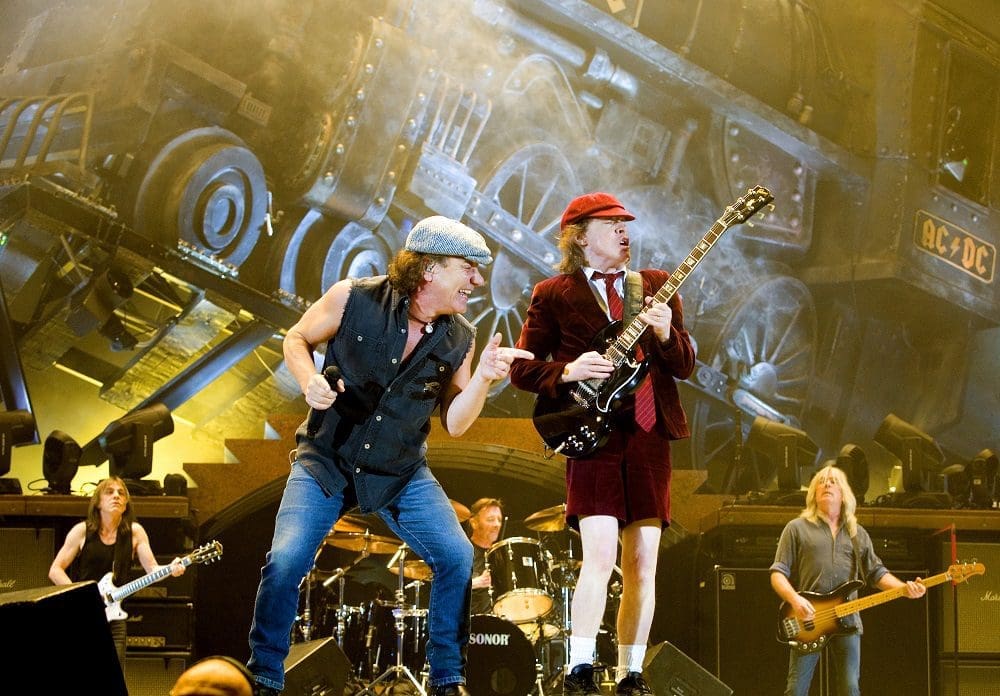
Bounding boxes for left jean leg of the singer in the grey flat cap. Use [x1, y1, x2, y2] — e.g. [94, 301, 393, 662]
[247, 462, 344, 690]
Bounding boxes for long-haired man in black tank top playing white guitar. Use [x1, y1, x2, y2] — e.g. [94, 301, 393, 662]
[49, 476, 185, 671]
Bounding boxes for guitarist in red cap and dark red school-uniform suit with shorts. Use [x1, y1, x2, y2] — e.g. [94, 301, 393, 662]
[510, 192, 695, 696]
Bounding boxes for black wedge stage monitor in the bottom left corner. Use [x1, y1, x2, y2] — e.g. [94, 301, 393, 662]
[0, 582, 128, 696]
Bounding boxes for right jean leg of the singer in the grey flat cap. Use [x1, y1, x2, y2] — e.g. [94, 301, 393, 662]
[380, 469, 472, 686]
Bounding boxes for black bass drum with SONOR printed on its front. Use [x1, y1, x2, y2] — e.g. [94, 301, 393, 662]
[466, 614, 536, 696]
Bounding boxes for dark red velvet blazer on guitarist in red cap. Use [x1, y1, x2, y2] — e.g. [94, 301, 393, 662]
[510, 269, 695, 440]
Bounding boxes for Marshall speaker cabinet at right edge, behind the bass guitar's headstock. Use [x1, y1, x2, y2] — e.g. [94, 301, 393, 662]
[931, 542, 1000, 656]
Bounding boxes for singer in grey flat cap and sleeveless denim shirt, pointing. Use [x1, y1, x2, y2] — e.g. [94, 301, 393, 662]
[247, 216, 532, 696]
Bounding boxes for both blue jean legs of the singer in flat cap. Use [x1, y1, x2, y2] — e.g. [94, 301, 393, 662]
[247, 462, 472, 690]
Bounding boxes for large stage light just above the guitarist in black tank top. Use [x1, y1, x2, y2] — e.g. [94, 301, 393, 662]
[97, 404, 174, 493]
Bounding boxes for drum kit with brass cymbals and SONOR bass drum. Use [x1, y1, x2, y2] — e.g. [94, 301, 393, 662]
[293, 501, 612, 696]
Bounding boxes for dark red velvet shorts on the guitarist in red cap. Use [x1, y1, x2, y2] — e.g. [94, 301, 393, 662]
[566, 429, 671, 529]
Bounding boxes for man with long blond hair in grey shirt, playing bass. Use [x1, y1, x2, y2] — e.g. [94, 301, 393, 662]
[771, 465, 927, 696]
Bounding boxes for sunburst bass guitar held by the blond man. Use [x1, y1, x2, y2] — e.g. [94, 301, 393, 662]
[778, 563, 986, 653]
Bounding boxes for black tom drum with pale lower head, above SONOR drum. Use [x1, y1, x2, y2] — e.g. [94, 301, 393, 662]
[486, 537, 553, 623]
